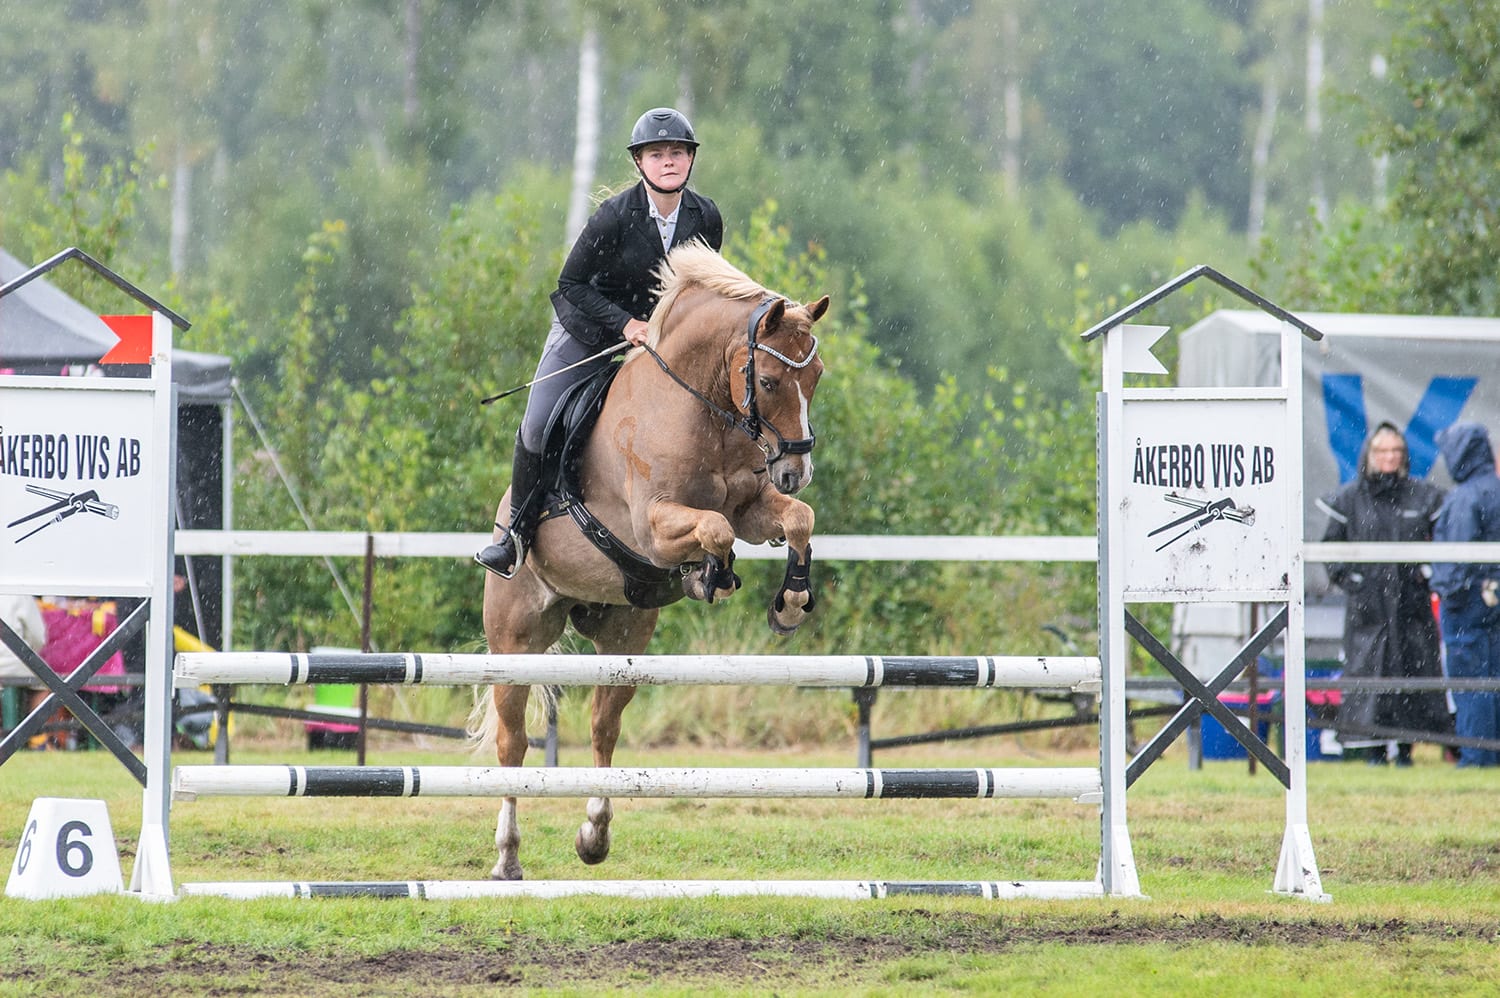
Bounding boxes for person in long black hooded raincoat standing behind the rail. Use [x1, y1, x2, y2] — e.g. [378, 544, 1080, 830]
[1317, 423, 1452, 765]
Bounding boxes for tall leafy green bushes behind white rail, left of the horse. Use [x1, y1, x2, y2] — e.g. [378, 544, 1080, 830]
[228, 174, 561, 650]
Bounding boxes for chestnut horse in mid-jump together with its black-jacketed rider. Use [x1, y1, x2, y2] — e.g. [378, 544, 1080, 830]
[474, 108, 828, 879]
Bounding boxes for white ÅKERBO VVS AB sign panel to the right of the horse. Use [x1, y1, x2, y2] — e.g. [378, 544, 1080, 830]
[1118, 399, 1298, 599]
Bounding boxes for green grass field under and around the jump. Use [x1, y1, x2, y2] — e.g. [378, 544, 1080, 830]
[0, 738, 1500, 996]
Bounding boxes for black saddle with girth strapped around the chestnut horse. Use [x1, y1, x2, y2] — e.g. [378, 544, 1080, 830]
[537, 363, 683, 609]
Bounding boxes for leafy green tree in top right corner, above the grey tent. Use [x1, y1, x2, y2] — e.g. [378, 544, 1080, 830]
[1256, 2, 1500, 314]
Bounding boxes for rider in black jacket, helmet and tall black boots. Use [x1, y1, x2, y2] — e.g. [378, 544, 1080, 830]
[474, 108, 725, 579]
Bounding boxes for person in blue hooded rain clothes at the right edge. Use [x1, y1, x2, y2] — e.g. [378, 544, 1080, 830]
[1433, 423, 1500, 765]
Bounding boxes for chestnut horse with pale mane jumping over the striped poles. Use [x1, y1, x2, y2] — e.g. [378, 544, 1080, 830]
[476, 243, 828, 879]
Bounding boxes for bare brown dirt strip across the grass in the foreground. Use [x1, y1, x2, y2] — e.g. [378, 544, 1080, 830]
[9, 909, 1500, 998]
